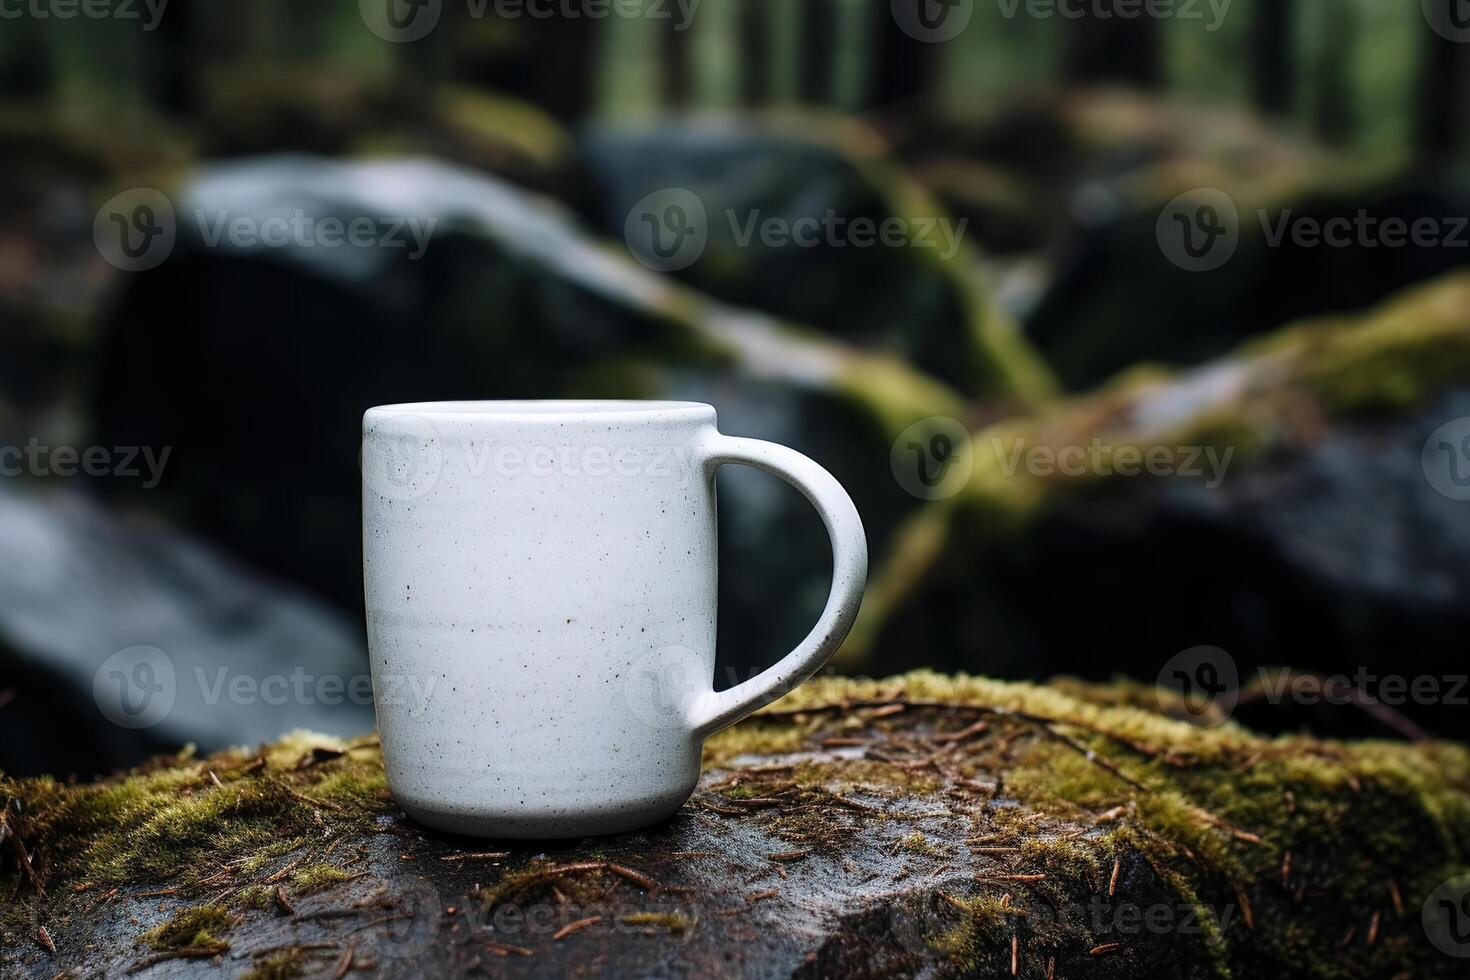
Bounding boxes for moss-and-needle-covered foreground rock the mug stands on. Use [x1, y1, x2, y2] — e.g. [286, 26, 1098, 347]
[0, 673, 1470, 979]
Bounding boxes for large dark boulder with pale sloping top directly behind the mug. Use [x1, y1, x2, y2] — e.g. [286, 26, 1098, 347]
[96, 157, 963, 690]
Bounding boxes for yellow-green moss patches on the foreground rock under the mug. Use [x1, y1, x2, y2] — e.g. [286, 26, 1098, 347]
[0, 671, 1470, 980]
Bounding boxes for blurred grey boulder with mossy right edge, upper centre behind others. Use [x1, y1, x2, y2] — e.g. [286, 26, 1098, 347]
[578, 115, 1051, 404]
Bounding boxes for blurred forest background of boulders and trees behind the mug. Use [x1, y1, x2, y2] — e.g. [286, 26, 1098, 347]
[0, 0, 1470, 776]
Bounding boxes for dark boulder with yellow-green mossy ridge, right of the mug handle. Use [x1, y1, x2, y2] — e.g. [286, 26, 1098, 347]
[845, 275, 1470, 733]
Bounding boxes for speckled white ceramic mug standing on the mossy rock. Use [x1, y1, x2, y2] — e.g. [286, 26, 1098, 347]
[362, 401, 867, 837]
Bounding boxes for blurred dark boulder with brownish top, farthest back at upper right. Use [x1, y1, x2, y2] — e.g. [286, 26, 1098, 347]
[898, 91, 1470, 391]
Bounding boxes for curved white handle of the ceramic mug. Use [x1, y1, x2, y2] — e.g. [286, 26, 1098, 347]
[691, 432, 867, 738]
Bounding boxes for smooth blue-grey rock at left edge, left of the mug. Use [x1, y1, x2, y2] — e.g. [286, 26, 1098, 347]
[0, 488, 372, 776]
